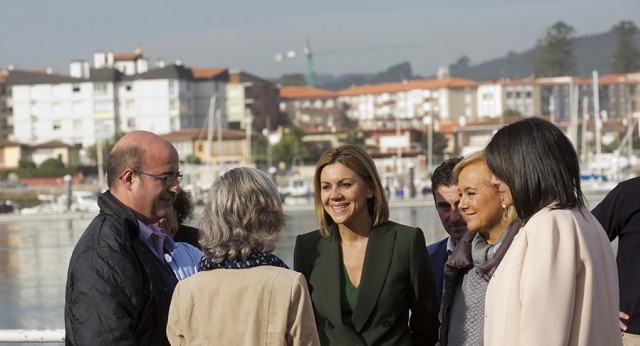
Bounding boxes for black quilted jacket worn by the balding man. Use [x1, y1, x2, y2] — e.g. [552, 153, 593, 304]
[64, 191, 177, 345]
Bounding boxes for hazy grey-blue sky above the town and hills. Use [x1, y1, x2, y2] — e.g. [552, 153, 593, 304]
[0, 0, 640, 77]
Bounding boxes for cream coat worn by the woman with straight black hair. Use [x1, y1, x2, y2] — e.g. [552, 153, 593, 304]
[484, 208, 622, 346]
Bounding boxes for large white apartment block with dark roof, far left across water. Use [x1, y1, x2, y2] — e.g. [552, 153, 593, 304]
[5, 52, 228, 163]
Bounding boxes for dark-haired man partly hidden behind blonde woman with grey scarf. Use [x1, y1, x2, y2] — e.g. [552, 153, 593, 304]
[427, 157, 467, 298]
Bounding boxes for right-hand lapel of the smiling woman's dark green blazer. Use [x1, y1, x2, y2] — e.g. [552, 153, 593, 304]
[350, 222, 396, 332]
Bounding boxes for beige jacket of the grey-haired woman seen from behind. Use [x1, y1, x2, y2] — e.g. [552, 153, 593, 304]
[167, 266, 320, 346]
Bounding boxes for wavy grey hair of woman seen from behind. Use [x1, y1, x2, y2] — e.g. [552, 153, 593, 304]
[200, 167, 286, 263]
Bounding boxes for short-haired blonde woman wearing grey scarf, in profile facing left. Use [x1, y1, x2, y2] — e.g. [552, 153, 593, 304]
[440, 152, 519, 346]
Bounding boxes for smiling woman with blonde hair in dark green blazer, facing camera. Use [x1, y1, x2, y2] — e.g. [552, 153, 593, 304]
[294, 145, 438, 345]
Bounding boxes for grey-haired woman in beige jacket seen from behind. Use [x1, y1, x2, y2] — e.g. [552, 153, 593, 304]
[167, 167, 319, 345]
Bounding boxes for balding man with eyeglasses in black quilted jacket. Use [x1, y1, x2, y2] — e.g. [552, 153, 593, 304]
[65, 131, 182, 345]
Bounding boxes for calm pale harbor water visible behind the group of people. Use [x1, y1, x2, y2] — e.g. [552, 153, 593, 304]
[0, 195, 603, 336]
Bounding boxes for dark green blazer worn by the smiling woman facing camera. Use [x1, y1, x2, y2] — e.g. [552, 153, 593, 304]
[294, 221, 439, 345]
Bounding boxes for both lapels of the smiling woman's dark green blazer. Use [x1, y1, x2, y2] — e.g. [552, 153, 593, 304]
[317, 221, 395, 332]
